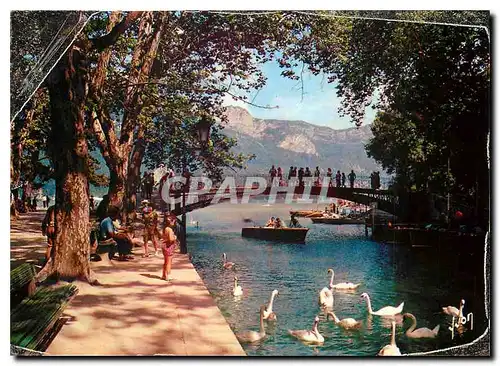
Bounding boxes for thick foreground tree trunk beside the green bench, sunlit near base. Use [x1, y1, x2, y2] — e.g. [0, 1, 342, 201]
[37, 42, 93, 282]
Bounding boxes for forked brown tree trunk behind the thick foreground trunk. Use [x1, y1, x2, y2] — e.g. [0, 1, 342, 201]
[92, 12, 167, 219]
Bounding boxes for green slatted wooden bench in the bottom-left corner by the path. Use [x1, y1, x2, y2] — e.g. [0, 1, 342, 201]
[10, 263, 78, 355]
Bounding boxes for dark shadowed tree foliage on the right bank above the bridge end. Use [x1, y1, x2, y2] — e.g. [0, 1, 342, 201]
[350, 13, 490, 217]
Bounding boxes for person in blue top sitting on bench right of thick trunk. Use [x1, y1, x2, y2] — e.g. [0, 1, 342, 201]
[99, 206, 134, 261]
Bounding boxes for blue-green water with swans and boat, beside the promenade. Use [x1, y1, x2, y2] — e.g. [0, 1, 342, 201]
[186, 202, 486, 356]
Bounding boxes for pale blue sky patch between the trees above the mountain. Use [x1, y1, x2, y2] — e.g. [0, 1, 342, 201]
[224, 62, 376, 129]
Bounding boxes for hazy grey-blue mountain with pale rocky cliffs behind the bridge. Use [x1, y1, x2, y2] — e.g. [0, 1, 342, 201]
[224, 106, 382, 175]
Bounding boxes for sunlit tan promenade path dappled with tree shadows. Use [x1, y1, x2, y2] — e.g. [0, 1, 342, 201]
[11, 212, 245, 356]
